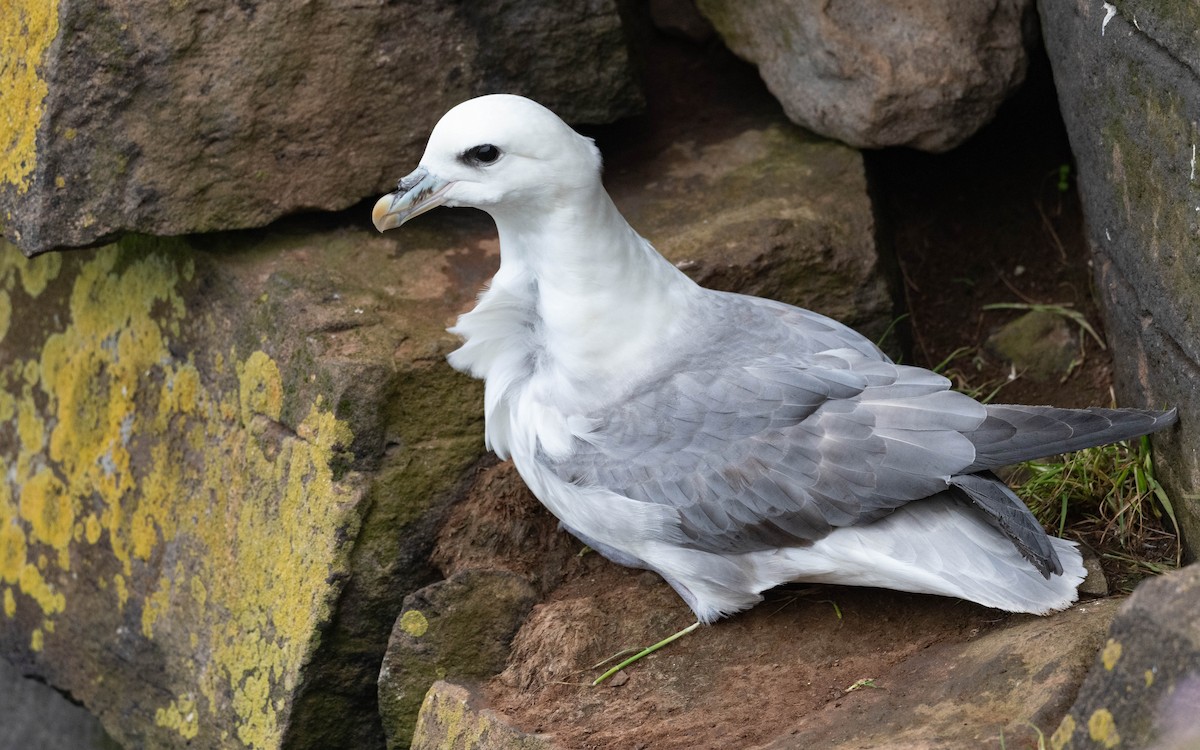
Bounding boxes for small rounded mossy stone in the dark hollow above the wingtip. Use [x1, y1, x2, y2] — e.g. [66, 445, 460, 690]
[988, 310, 1079, 380]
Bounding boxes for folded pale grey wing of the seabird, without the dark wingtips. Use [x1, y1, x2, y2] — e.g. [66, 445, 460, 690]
[540, 349, 986, 552]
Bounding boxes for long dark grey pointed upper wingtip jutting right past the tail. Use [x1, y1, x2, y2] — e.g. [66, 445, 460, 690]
[964, 404, 1176, 474]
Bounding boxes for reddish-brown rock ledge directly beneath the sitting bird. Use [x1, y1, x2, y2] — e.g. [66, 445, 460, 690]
[414, 559, 1120, 750]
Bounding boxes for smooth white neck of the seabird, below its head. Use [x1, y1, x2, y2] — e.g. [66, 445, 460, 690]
[496, 185, 701, 383]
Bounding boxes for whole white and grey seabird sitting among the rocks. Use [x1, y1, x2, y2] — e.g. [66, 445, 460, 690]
[373, 95, 1175, 623]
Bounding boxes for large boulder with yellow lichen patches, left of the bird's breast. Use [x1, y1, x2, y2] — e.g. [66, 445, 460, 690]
[0, 216, 494, 748]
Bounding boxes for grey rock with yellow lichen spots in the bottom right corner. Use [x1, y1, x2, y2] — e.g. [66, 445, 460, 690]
[1050, 565, 1200, 750]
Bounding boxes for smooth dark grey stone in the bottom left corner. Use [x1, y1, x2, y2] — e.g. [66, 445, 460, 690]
[0, 658, 120, 750]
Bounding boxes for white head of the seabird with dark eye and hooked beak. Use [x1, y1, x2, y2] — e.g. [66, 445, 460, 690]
[372, 94, 600, 232]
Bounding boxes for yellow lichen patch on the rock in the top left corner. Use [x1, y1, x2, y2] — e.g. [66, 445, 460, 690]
[0, 2, 59, 193]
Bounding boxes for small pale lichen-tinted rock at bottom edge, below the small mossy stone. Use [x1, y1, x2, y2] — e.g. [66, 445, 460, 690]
[413, 680, 554, 750]
